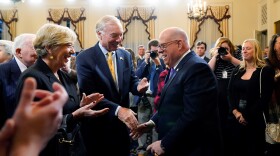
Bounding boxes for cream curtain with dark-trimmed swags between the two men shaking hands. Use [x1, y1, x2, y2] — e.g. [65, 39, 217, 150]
[117, 7, 156, 55]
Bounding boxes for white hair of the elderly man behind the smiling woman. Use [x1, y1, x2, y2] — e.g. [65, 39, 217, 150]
[13, 33, 36, 54]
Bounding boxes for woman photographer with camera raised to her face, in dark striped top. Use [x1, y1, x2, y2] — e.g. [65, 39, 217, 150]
[208, 37, 242, 155]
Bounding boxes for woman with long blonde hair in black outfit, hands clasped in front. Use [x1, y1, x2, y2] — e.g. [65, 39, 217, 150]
[229, 39, 275, 156]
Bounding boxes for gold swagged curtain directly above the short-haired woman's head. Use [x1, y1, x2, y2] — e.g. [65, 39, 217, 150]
[47, 8, 86, 49]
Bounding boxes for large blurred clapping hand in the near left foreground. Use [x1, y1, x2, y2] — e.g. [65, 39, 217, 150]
[10, 78, 68, 155]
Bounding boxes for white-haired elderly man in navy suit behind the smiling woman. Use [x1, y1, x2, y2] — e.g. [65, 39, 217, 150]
[0, 34, 37, 127]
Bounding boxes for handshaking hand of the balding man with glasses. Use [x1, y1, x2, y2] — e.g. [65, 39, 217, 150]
[129, 120, 155, 140]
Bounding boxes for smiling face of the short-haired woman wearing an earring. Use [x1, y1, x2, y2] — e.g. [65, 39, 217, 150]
[49, 43, 75, 69]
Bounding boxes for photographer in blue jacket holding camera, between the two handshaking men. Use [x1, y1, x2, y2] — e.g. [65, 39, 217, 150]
[135, 40, 165, 156]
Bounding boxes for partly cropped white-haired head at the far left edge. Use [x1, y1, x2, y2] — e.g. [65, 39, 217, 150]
[0, 40, 13, 64]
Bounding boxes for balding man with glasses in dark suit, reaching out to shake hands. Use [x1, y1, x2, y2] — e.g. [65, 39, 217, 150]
[132, 27, 221, 156]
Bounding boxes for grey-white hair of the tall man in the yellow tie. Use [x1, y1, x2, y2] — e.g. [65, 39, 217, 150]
[95, 15, 123, 38]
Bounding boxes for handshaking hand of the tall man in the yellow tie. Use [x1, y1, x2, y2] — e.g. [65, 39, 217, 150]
[118, 107, 138, 130]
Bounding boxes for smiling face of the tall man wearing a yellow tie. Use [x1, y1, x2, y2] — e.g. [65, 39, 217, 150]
[97, 22, 123, 51]
